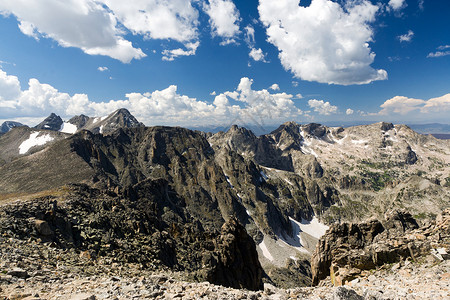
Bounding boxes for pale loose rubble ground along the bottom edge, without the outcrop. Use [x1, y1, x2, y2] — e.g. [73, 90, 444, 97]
[0, 237, 450, 300]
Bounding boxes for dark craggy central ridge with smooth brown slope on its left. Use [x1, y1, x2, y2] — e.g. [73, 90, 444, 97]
[0, 123, 316, 288]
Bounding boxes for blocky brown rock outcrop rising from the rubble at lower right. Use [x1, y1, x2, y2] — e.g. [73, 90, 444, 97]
[311, 210, 450, 285]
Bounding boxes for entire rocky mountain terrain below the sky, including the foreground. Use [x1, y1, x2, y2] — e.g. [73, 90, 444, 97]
[0, 109, 450, 299]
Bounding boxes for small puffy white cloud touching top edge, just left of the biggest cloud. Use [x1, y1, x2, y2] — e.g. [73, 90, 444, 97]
[203, 0, 240, 45]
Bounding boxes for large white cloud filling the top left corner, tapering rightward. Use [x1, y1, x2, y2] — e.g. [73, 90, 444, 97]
[0, 0, 146, 63]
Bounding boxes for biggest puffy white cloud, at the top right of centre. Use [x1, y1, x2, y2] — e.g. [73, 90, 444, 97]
[258, 0, 387, 85]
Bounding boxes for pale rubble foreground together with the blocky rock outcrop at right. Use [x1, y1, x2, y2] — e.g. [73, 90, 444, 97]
[0, 206, 450, 300]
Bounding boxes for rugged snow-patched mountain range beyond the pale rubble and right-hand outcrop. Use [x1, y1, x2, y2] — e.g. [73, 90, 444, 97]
[0, 109, 450, 289]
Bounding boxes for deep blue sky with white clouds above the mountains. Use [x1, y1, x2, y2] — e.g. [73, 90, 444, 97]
[0, 0, 450, 126]
